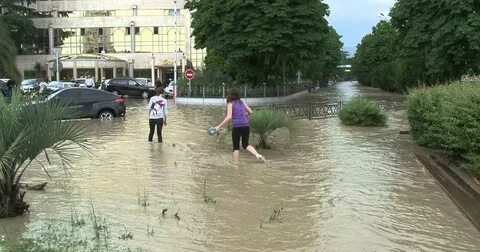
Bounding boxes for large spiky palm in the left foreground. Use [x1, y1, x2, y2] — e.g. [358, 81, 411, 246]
[0, 91, 88, 218]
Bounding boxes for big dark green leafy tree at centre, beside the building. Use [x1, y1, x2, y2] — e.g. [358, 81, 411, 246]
[185, 0, 341, 84]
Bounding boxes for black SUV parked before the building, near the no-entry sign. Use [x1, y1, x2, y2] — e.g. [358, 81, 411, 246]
[107, 78, 155, 99]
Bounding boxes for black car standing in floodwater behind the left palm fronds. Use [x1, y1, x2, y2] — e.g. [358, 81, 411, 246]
[46, 87, 126, 119]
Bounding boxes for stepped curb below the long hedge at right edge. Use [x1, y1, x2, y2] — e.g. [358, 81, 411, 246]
[415, 153, 480, 231]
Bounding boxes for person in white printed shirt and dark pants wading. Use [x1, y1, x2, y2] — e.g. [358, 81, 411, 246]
[147, 87, 168, 143]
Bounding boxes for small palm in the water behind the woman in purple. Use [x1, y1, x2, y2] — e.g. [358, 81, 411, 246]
[250, 109, 295, 149]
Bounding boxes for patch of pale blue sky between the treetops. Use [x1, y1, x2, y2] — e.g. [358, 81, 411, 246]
[324, 0, 395, 53]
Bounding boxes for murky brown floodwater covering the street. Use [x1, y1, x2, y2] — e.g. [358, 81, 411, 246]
[0, 83, 480, 251]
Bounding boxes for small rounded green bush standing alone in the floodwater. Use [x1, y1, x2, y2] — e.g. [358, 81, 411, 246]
[339, 98, 387, 126]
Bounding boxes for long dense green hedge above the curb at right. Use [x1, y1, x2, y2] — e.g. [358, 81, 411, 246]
[407, 83, 480, 175]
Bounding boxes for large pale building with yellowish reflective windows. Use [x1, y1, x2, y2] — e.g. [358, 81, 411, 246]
[17, 0, 205, 81]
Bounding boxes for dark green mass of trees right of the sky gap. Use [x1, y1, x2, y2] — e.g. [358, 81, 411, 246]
[353, 0, 480, 92]
